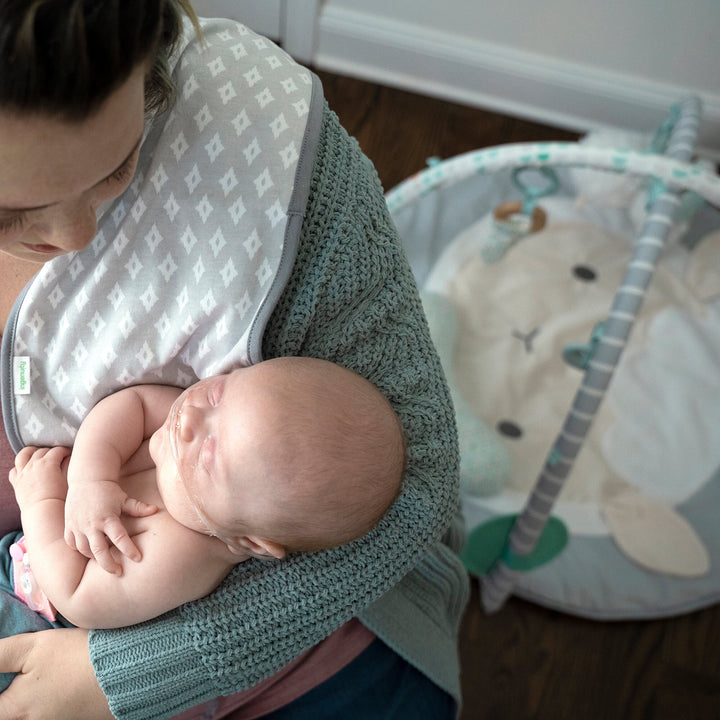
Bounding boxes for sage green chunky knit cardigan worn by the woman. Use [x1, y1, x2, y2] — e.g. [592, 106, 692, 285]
[90, 107, 467, 720]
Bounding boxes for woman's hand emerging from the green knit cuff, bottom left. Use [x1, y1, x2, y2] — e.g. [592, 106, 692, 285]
[0, 629, 113, 720]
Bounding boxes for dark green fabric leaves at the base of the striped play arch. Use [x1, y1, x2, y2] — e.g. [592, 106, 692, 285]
[460, 514, 568, 576]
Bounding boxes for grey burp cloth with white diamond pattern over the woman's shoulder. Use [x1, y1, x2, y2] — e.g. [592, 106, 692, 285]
[4, 20, 321, 445]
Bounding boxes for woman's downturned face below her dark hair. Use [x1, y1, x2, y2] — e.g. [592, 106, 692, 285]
[0, 66, 145, 263]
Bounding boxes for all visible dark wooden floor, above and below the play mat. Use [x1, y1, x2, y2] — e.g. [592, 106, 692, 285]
[319, 73, 720, 720]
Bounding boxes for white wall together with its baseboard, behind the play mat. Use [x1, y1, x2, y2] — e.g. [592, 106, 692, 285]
[316, 0, 720, 157]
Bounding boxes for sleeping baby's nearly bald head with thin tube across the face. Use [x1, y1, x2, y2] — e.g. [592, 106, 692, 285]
[155, 357, 405, 557]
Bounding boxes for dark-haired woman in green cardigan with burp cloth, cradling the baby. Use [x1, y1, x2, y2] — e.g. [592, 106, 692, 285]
[0, 0, 467, 720]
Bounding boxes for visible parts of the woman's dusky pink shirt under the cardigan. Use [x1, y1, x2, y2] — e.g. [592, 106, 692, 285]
[0, 394, 375, 720]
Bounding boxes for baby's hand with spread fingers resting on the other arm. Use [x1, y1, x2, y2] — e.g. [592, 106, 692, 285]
[65, 480, 157, 575]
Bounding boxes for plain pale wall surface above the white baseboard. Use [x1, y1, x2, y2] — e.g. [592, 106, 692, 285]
[326, 0, 720, 93]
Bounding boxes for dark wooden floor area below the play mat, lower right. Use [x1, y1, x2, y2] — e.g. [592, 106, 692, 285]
[460, 581, 720, 720]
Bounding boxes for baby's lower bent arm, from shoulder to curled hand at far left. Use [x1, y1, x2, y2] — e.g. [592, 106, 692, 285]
[10, 447, 236, 628]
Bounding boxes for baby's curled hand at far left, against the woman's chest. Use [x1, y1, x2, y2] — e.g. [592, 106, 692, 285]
[8, 446, 70, 509]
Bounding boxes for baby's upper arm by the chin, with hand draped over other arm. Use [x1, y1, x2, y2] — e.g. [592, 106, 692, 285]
[64, 385, 181, 573]
